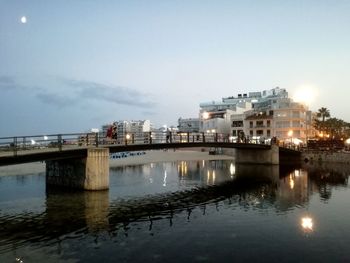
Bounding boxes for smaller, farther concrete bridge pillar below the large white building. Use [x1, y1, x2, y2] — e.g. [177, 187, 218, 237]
[235, 145, 280, 164]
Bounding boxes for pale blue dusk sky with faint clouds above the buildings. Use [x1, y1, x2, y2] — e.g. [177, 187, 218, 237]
[0, 0, 350, 137]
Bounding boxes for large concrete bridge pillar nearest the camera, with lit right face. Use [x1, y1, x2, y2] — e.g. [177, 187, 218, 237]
[46, 148, 109, 190]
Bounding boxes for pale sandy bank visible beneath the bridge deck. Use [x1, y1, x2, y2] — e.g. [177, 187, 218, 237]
[0, 150, 234, 176]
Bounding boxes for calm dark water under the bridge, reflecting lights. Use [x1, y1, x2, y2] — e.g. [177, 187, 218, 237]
[0, 161, 350, 262]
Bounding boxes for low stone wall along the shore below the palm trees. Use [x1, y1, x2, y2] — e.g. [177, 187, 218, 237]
[301, 151, 350, 164]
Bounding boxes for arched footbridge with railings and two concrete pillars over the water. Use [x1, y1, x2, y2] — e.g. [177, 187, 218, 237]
[0, 132, 301, 190]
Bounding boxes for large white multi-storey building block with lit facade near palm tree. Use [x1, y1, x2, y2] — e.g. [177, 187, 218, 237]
[199, 87, 313, 142]
